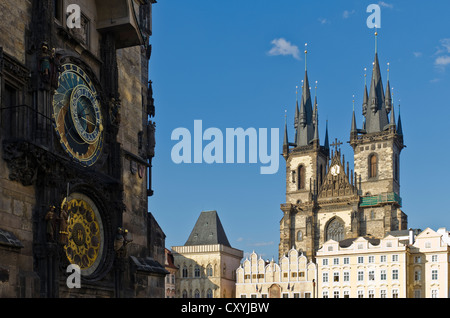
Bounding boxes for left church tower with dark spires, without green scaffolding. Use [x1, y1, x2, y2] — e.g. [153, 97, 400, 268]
[279, 47, 329, 257]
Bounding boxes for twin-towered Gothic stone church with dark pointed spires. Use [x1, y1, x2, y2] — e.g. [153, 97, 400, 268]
[279, 39, 407, 260]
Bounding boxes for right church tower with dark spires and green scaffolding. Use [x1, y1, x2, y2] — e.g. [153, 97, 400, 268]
[350, 33, 406, 237]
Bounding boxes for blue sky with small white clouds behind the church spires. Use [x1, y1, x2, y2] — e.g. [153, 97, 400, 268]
[149, 0, 450, 259]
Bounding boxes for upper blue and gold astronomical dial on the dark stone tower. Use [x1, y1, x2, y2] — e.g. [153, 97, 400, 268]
[53, 63, 103, 166]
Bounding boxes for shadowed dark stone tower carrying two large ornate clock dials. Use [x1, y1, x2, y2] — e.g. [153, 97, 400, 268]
[0, 0, 166, 297]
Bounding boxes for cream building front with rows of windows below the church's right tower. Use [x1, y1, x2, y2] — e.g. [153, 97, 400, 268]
[317, 228, 450, 298]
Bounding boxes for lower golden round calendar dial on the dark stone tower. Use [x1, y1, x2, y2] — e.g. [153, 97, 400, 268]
[65, 193, 104, 276]
